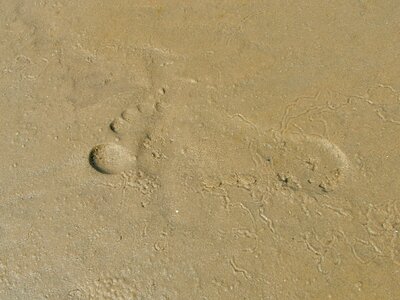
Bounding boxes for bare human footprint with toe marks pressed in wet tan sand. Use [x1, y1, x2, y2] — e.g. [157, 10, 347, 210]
[90, 91, 351, 202]
